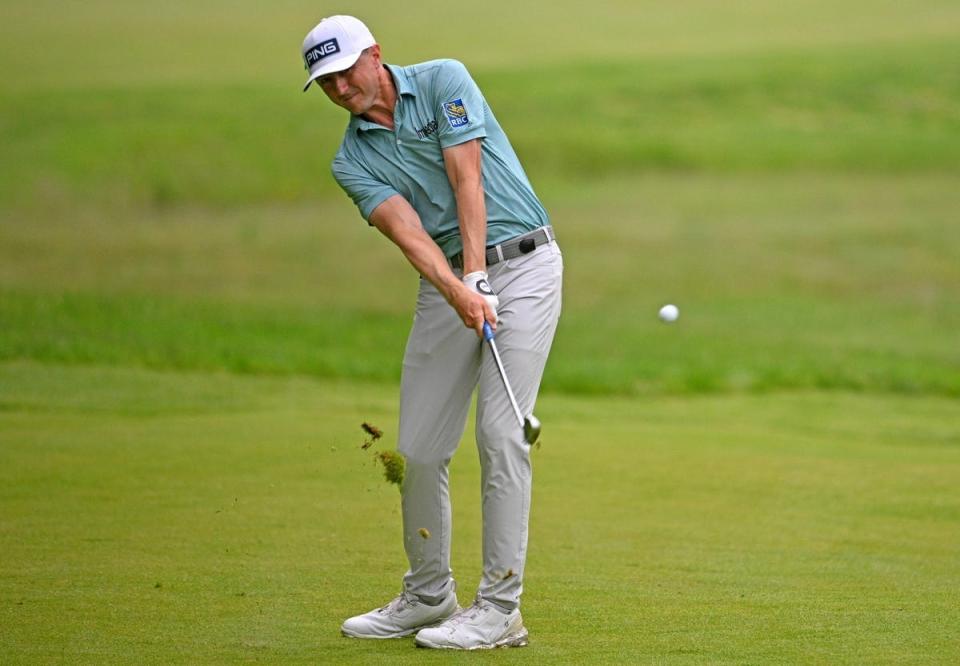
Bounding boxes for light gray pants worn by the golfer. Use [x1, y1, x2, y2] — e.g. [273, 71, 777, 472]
[398, 237, 563, 610]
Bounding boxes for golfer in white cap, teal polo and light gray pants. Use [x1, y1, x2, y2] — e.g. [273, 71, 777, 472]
[303, 16, 563, 649]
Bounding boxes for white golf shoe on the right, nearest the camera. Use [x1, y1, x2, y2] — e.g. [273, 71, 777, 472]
[416, 596, 527, 650]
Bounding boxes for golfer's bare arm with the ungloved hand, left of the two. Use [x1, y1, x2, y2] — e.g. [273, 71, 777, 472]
[370, 195, 496, 336]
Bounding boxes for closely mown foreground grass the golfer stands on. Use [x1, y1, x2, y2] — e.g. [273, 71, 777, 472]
[0, 362, 960, 664]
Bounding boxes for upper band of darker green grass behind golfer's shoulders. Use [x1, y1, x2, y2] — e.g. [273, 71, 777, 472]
[0, 35, 960, 210]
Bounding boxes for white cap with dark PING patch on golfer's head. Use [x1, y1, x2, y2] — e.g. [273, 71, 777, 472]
[303, 16, 377, 91]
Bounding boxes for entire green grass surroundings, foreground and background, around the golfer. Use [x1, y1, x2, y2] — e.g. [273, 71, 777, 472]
[0, 0, 960, 663]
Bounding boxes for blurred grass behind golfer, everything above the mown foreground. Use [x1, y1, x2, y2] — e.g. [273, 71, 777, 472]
[0, 0, 960, 396]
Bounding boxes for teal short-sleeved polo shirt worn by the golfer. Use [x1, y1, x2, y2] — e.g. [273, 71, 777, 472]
[332, 60, 548, 257]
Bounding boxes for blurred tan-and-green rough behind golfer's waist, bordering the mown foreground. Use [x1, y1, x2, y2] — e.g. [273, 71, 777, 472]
[0, 174, 960, 397]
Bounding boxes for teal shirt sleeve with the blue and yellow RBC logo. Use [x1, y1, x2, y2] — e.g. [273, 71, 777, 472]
[434, 60, 487, 148]
